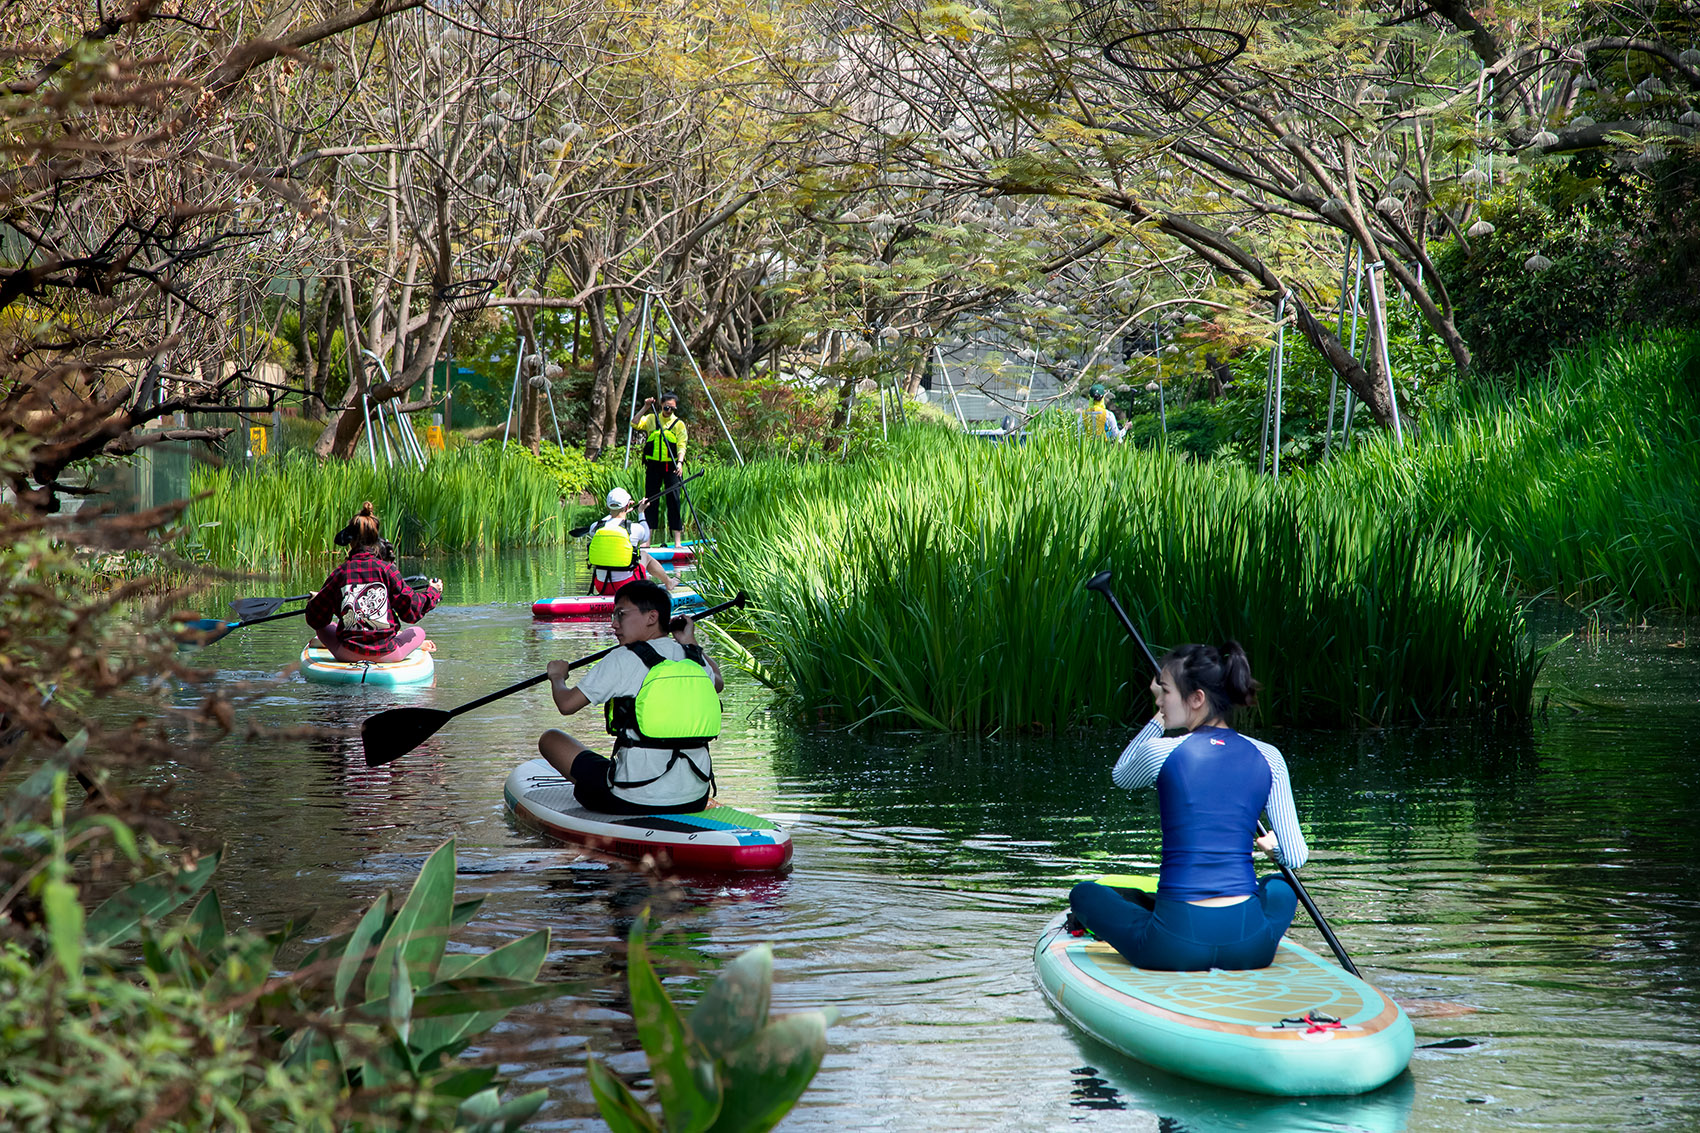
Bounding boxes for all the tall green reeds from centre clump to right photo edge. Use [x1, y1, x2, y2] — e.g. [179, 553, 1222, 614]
[697, 333, 1700, 732]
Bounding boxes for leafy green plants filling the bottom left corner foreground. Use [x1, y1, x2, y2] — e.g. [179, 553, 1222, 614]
[0, 799, 563, 1133]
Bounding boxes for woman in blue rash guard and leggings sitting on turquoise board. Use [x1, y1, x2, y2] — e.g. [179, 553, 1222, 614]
[1069, 641, 1309, 971]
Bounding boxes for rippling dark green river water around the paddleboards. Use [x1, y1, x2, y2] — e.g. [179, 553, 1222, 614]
[136, 553, 1700, 1133]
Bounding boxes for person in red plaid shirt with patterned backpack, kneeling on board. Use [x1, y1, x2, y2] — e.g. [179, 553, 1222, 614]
[306, 500, 442, 662]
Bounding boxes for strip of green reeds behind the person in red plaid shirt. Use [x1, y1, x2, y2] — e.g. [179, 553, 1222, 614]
[187, 444, 564, 570]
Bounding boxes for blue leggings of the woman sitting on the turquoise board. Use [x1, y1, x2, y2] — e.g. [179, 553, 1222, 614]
[1068, 874, 1299, 971]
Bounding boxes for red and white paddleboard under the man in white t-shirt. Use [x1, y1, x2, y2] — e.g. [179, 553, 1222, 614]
[502, 759, 791, 873]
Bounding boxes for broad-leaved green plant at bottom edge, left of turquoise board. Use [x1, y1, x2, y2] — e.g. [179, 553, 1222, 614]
[590, 915, 836, 1133]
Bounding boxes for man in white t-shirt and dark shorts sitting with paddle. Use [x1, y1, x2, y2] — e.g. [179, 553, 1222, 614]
[537, 582, 723, 815]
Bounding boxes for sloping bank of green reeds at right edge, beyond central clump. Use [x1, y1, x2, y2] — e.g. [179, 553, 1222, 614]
[1307, 332, 1700, 611]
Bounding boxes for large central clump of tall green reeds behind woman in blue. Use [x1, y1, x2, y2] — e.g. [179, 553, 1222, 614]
[699, 429, 1539, 732]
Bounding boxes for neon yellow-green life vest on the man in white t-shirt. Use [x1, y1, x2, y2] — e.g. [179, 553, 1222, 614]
[605, 641, 721, 789]
